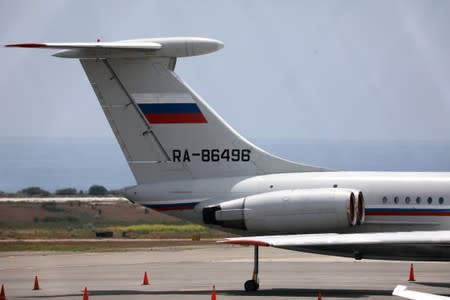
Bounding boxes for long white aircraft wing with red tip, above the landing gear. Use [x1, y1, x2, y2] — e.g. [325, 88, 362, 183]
[222, 230, 450, 247]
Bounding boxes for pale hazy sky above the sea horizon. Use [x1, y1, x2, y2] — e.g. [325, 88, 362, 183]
[0, 0, 450, 140]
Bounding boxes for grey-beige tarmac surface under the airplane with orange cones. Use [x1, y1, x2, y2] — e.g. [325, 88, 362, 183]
[0, 244, 450, 300]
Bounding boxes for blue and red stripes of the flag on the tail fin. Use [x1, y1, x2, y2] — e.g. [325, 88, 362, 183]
[138, 103, 208, 124]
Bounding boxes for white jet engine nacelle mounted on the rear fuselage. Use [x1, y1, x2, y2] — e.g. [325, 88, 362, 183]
[203, 188, 365, 234]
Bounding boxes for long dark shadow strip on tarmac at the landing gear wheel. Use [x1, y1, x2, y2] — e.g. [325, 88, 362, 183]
[19, 289, 392, 298]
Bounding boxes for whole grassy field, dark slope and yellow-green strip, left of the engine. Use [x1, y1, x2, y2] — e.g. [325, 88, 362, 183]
[0, 202, 236, 251]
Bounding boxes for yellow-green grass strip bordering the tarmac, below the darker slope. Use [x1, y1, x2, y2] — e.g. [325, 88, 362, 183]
[0, 219, 227, 252]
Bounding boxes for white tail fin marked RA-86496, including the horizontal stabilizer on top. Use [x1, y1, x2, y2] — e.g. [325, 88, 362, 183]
[8, 38, 325, 184]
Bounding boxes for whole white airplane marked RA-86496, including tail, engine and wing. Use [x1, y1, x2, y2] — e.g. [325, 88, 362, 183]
[6, 37, 450, 291]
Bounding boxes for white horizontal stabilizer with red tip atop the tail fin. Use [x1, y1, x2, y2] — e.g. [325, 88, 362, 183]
[5, 37, 223, 59]
